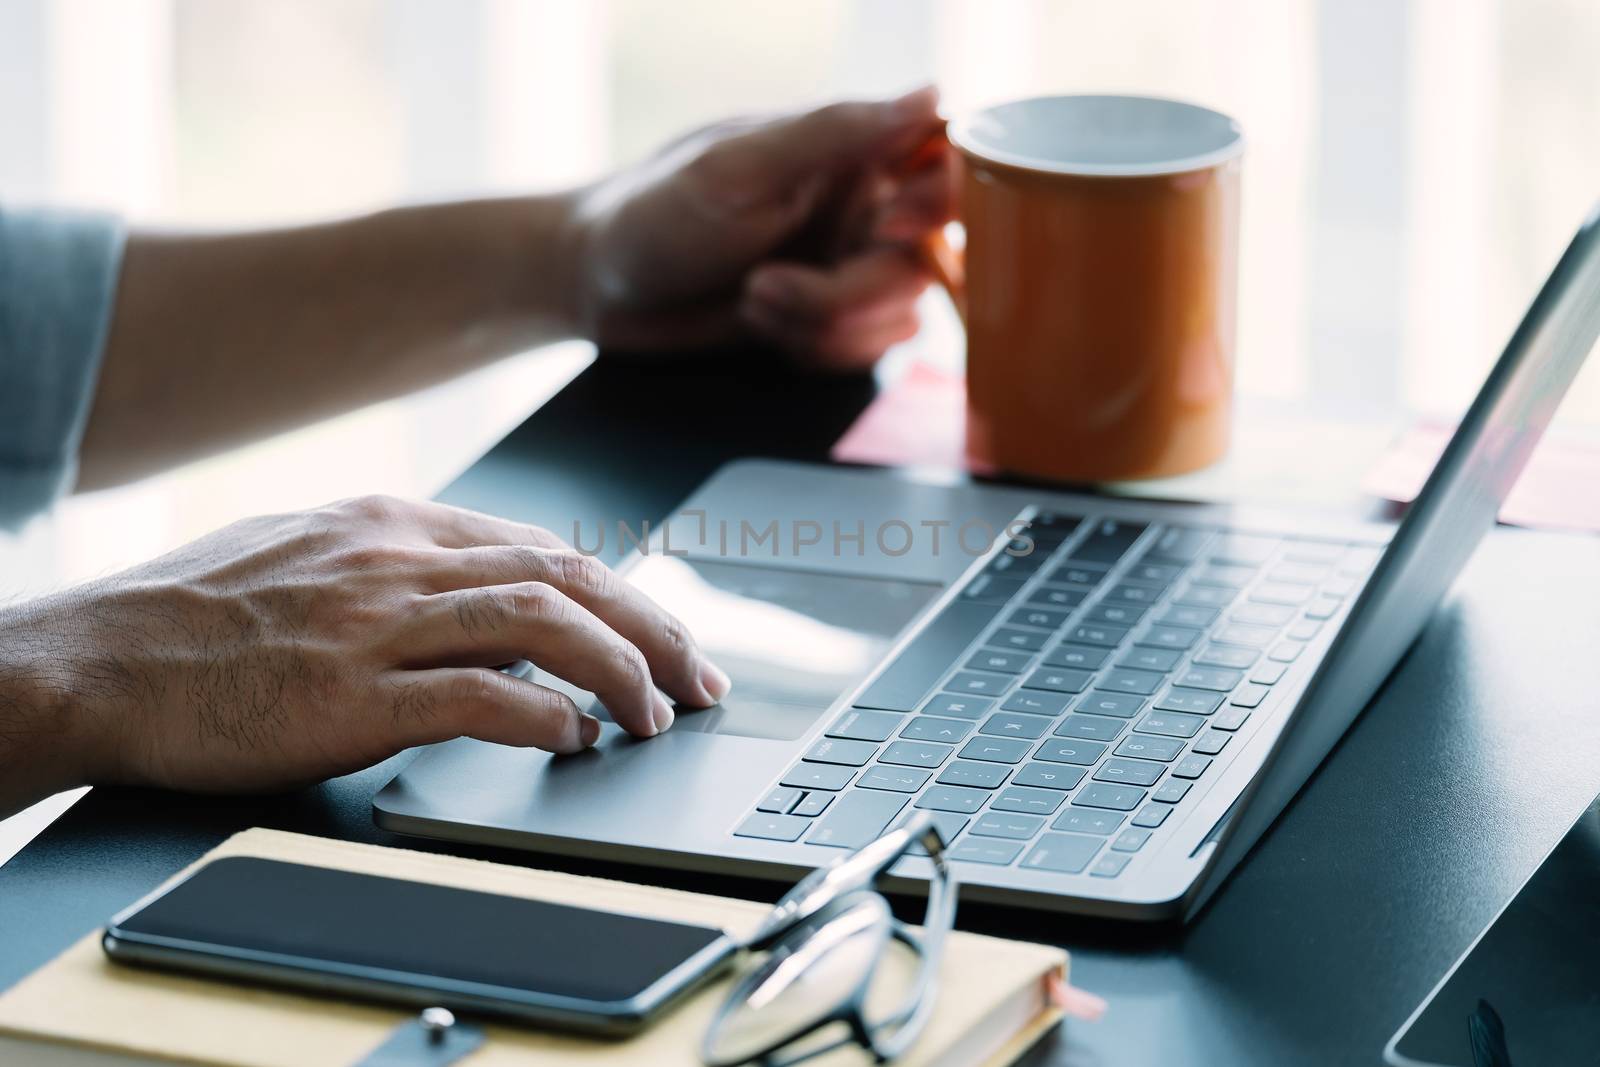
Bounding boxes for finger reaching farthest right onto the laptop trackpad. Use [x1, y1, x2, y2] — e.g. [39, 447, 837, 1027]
[412, 545, 728, 707]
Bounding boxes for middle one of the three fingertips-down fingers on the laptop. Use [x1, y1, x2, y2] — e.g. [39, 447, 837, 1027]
[406, 582, 672, 737]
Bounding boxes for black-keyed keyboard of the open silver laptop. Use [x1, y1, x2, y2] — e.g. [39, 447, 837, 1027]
[734, 512, 1378, 878]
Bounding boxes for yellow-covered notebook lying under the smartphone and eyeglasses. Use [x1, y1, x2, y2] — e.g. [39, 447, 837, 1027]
[0, 829, 1067, 1067]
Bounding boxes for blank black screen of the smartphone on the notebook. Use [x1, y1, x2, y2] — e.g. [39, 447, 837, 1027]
[107, 856, 725, 1022]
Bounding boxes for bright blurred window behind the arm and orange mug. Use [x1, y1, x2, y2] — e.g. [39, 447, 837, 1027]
[0, 0, 1600, 566]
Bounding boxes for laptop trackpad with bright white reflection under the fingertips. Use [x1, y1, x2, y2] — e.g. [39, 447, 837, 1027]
[563, 555, 939, 741]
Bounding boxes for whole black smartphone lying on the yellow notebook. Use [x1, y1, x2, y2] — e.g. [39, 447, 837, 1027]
[101, 856, 734, 1037]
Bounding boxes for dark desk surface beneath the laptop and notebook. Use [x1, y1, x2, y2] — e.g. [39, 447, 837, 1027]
[0, 360, 1600, 1067]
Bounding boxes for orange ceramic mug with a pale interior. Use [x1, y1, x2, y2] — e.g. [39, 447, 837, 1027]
[931, 96, 1243, 482]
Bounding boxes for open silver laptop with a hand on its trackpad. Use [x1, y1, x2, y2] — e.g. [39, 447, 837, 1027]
[373, 204, 1600, 920]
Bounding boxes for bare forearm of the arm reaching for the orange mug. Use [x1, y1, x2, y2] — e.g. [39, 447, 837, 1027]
[78, 197, 588, 488]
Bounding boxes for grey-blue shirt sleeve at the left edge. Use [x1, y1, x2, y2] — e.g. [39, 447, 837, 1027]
[0, 210, 123, 526]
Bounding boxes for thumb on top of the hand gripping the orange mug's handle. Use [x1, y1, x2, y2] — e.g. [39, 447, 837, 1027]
[738, 85, 941, 182]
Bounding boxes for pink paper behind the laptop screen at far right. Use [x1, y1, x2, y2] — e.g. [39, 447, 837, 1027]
[1362, 421, 1600, 533]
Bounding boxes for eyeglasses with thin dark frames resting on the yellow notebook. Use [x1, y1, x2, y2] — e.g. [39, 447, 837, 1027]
[701, 811, 955, 1067]
